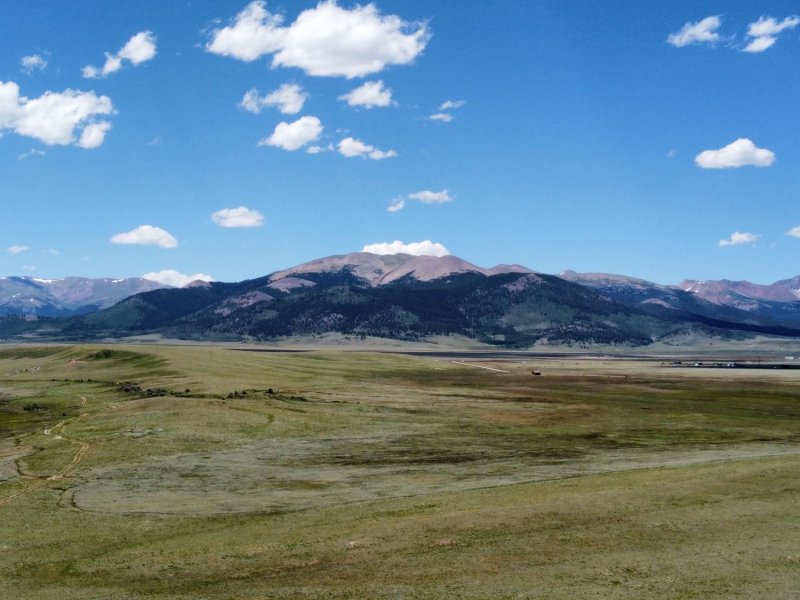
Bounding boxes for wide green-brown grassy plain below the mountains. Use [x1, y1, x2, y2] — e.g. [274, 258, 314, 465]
[0, 345, 800, 600]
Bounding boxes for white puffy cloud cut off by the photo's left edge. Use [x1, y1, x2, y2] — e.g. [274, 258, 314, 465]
[0, 81, 114, 148]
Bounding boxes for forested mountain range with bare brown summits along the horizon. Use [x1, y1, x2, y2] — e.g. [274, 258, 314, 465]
[0, 252, 800, 347]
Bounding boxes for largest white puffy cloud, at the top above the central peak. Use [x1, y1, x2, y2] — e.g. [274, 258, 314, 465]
[206, 0, 430, 79]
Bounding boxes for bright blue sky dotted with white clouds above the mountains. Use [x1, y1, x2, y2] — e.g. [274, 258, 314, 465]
[0, 0, 800, 283]
